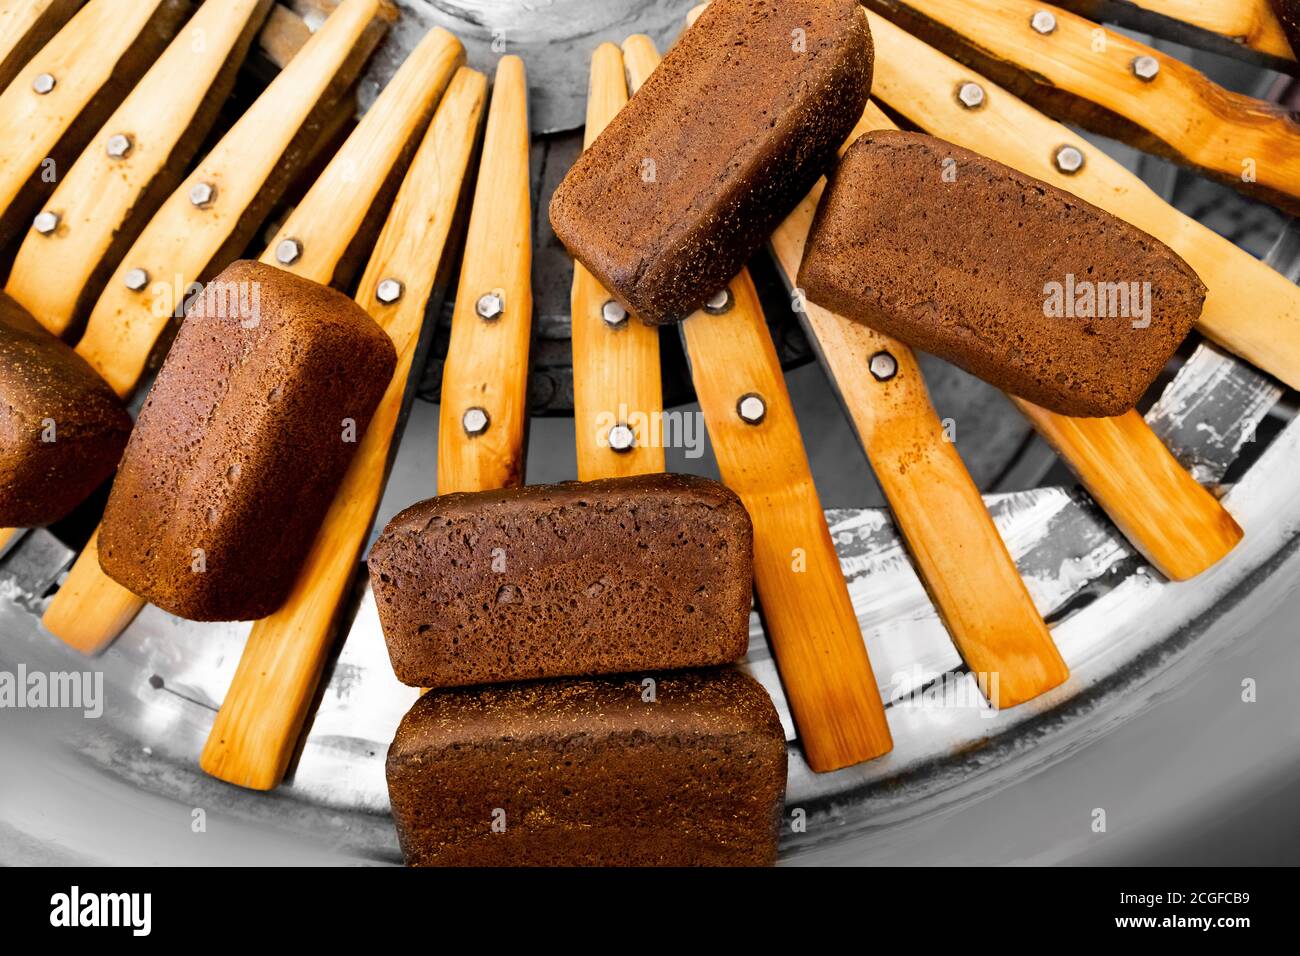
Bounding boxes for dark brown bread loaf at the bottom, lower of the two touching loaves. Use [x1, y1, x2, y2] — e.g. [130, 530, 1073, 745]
[387, 667, 785, 866]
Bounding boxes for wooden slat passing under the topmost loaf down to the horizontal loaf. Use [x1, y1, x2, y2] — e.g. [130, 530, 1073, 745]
[572, 43, 664, 481]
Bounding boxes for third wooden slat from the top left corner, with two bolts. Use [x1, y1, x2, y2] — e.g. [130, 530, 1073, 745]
[5, 0, 272, 336]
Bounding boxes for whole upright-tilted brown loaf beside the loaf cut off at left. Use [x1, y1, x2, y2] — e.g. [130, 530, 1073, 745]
[99, 261, 397, 620]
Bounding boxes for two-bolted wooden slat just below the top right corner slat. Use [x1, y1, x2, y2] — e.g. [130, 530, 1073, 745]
[875, 0, 1300, 213]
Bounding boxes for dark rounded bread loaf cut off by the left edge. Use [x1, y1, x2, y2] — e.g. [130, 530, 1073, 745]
[0, 293, 131, 528]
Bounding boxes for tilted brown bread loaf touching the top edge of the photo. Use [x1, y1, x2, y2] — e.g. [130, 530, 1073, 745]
[550, 0, 872, 324]
